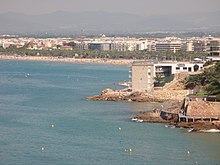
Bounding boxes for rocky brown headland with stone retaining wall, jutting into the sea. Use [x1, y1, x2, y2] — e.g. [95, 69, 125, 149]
[88, 61, 220, 132]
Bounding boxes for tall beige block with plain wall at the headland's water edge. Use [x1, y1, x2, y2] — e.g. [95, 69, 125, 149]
[131, 62, 154, 92]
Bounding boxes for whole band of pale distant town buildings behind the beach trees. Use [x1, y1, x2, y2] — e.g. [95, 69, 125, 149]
[0, 36, 220, 56]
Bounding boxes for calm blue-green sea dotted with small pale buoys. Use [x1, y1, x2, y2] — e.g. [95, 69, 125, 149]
[0, 60, 220, 165]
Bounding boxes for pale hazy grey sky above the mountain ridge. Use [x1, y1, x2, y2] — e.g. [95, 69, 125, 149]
[0, 0, 220, 16]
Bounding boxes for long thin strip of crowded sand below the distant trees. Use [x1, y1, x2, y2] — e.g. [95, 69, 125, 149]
[0, 55, 134, 65]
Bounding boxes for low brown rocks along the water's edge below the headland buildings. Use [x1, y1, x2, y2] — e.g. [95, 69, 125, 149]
[87, 89, 220, 132]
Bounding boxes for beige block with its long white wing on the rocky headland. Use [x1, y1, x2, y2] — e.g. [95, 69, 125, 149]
[131, 61, 203, 92]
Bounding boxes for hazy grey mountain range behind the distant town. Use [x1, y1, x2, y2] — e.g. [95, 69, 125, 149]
[0, 11, 220, 34]
